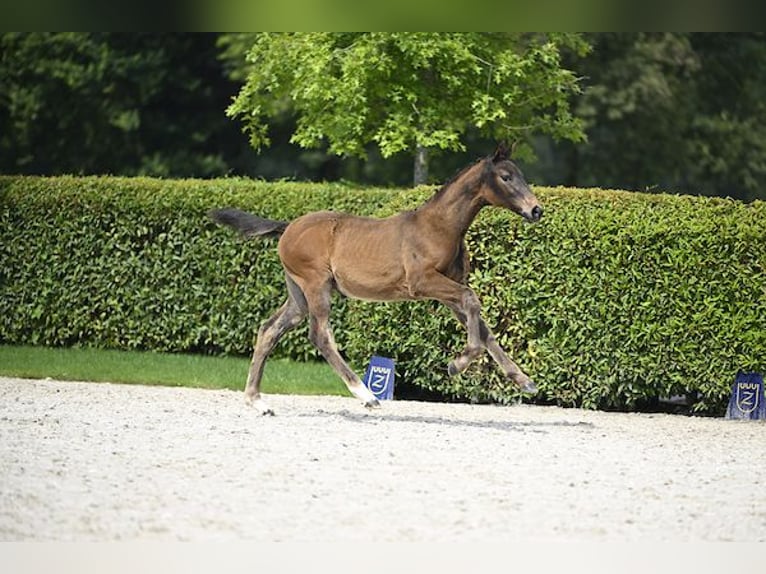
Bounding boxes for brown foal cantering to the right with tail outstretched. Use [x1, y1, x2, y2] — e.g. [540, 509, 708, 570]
[208, 143, 543, 415]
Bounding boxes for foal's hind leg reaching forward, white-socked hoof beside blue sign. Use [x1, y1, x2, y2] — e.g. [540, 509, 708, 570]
[306, 283, 380, 408]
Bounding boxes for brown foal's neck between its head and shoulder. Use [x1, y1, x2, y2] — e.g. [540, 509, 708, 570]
[419, 169, 484, 240]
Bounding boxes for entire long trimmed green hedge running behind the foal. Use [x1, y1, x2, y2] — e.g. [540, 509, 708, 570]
[0, 176, 766, 413]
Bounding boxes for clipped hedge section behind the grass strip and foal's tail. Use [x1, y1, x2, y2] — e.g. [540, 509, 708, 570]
[0, 177, 391, 358]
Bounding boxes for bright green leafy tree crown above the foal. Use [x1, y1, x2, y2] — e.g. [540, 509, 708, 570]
[227, 32, 588, 183]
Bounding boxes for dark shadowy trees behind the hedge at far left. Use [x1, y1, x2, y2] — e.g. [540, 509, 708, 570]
[0, 33, 252, 176]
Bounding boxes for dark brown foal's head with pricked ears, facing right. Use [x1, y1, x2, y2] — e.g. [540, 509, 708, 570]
[479, 143, 543, 221]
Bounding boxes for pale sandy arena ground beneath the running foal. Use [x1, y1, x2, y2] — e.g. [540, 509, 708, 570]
[0, 378, 766, 541]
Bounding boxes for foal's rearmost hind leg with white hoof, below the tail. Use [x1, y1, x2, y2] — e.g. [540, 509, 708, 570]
[245, 277, 308, 415]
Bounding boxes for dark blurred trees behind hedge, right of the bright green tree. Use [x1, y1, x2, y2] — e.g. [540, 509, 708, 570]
[554, 33, 766, 199]
